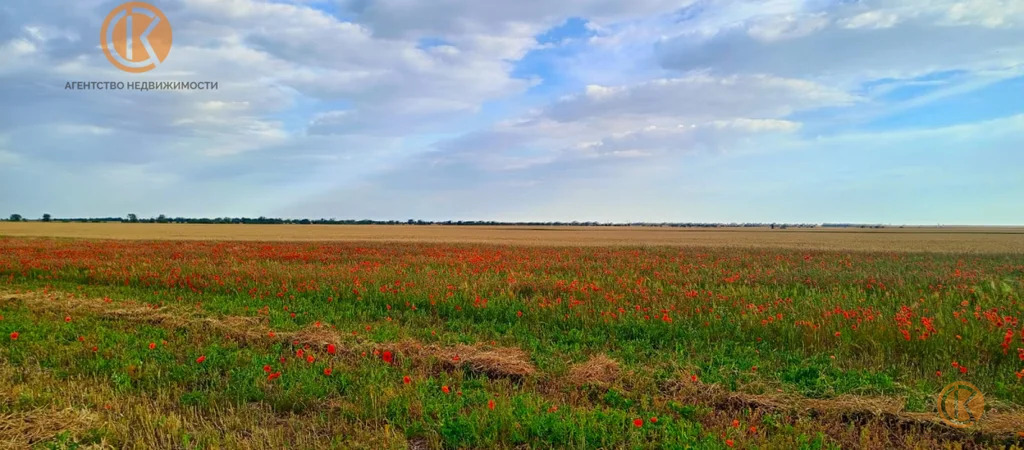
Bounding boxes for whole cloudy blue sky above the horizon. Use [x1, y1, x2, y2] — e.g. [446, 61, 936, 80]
[0, 0, 1024, 224]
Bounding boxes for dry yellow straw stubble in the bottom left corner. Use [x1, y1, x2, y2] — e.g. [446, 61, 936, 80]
[0, 364, 408, 449]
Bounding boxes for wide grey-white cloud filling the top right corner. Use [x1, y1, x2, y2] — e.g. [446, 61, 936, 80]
[658, 0, 1024, 85]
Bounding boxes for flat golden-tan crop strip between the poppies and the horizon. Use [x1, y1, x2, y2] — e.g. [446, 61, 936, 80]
[0, 222, 1024, 254]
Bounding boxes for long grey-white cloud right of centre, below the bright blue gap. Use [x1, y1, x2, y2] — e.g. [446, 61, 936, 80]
[429, 74, 839, 174]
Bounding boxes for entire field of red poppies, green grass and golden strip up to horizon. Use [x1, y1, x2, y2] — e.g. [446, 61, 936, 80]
[0, 223, 1024, 449]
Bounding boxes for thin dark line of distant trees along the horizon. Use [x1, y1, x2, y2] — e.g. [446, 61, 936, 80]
[0, 213, 897, 230]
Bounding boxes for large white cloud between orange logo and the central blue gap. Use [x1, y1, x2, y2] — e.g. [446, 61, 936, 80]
[174, 0, 536, 134]
